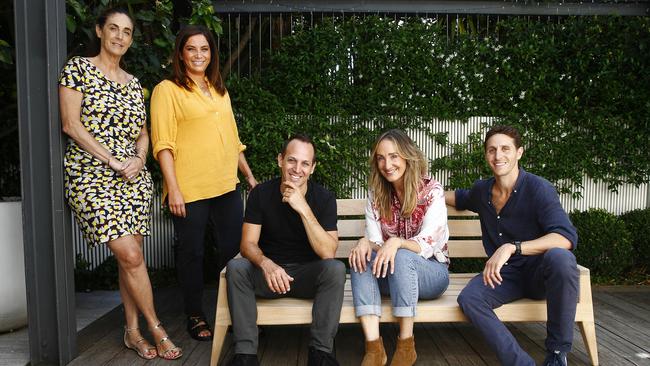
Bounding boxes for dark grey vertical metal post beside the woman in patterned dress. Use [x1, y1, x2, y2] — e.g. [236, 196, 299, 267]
[14, 0, 77, 365]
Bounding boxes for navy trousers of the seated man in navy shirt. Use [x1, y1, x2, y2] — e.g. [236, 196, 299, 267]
[458, 248, 579, 366]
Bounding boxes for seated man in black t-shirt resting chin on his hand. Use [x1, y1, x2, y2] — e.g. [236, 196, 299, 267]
[226, 135, 345, 366]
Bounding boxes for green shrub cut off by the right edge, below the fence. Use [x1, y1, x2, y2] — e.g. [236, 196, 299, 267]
[621, 208, 650, 271]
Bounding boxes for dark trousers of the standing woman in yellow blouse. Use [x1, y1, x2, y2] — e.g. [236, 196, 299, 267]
[173, 188, 243, 316]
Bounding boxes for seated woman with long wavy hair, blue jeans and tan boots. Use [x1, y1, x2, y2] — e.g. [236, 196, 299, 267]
[349, 130, 449, 366]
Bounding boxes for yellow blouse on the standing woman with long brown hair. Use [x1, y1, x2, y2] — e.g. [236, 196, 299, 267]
[151, 80, 246, 203]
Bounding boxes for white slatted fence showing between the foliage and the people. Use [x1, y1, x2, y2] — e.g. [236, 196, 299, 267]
[73, 117, 650, 268]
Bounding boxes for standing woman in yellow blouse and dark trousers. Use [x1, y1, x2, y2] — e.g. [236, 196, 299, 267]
[151, 26, 257, 341]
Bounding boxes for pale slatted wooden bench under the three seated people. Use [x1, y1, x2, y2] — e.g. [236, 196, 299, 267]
[210, 199, 598, 366]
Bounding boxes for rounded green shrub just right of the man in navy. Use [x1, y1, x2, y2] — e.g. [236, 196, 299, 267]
[570, 209, 634, 282]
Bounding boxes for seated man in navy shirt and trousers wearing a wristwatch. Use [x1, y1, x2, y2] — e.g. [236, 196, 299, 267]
[445, 126, 578, 366]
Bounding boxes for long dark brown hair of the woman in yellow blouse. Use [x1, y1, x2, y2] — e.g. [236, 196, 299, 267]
[170, 25, 226, 95]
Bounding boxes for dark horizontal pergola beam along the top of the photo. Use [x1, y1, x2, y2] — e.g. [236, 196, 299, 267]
[214, 0, 650, 16]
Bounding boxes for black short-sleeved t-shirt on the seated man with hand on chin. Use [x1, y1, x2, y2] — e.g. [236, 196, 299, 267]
[244, 178, 337, 264]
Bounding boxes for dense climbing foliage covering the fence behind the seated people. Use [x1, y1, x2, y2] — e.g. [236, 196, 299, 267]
[229, 16, 650, 197]
